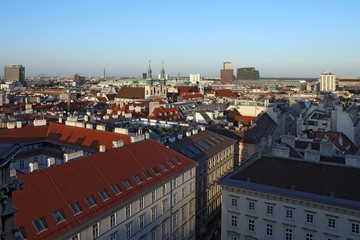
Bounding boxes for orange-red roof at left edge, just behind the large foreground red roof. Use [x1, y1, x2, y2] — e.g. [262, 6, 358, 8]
[0, 123, 131, 149]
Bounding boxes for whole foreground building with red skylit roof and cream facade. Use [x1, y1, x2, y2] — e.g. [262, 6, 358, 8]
[13, 140, 196, 240]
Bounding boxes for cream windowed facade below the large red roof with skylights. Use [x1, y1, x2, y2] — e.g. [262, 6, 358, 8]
[65, 167, 195, 240]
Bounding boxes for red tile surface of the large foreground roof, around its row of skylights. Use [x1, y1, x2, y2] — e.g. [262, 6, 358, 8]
[13, 140, 196, 239]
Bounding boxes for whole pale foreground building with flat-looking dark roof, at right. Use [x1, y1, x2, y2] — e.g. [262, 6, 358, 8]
[220, 156, 360, 240]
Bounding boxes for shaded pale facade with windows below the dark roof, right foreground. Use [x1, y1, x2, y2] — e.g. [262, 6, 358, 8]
[221, 186, 360, 240]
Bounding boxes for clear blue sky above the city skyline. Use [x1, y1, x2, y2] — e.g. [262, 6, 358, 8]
[0, 0, 360, 77]
